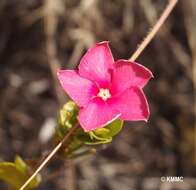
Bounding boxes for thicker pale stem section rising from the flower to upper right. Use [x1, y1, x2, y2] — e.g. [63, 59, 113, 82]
[129, 0, 178, 61]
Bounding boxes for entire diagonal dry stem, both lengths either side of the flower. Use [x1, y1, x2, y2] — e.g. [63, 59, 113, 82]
[19, 0, 178, 190]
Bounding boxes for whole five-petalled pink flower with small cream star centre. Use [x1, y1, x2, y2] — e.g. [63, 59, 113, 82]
[58, 42, 152, 132]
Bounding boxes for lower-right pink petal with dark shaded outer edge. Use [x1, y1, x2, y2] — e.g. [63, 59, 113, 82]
[109, 87, 150, 121]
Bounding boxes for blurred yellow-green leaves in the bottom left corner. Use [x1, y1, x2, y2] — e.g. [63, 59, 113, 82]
[0, 156, 41, 190]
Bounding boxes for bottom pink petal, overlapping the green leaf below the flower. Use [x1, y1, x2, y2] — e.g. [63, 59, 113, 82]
[78, 98, 120, 132]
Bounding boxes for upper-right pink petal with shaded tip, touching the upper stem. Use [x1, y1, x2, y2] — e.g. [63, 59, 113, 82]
[111, 60, 153, 93]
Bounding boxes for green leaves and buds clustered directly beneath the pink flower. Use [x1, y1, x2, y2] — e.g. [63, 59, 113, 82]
[54, 101, 123, 158]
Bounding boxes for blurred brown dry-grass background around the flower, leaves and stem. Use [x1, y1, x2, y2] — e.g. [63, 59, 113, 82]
[0, 0, 196, 190]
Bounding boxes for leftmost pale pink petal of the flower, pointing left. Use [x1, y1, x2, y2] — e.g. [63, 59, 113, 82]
[57, 70, 98, 107]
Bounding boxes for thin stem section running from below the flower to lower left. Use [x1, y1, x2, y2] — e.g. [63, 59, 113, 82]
[19, 125, 78, 190]
